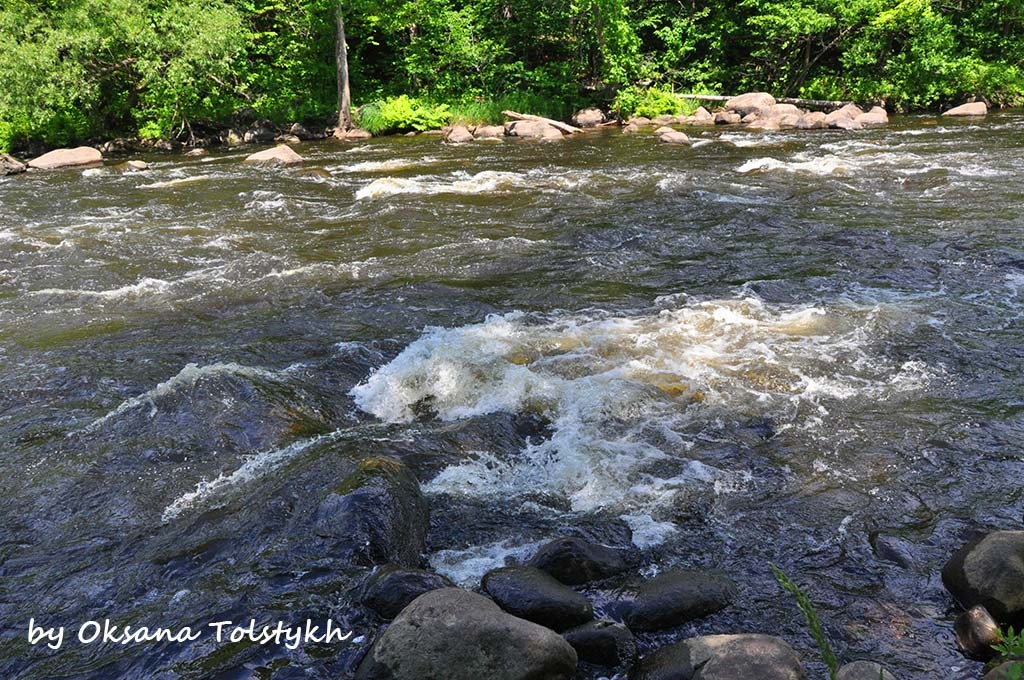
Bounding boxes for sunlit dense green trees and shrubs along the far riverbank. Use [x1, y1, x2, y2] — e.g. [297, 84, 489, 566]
[0, 0, 1024, 148]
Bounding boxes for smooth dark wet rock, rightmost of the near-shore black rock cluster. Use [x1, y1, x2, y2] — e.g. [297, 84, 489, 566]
[623, 570, 736, 631]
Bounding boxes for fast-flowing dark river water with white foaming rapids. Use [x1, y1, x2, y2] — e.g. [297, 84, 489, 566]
[0, 113, 1024, 679]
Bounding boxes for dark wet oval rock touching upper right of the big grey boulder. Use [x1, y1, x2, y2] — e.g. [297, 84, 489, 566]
[480, 566, 594, 631]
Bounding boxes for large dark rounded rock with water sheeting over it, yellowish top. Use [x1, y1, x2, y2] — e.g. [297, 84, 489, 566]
[314, 458, 429, 566]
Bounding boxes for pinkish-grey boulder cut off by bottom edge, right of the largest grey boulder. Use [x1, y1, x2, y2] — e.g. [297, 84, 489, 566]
[630, 635, 807, 680]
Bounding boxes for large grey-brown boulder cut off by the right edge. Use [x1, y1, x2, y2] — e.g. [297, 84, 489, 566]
[942, 532, 1024, 624]
